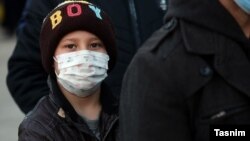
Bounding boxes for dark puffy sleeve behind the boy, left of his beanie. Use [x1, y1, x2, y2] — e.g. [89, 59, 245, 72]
[7, 0, 57, 113]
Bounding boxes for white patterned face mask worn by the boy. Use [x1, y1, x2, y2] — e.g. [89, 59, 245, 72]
[54, 50, 109, 97]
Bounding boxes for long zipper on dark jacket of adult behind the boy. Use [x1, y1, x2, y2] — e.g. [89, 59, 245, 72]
[128, 0, 141, 48]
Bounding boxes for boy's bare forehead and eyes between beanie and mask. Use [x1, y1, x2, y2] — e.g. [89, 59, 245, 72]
[54, 30, 107, 73]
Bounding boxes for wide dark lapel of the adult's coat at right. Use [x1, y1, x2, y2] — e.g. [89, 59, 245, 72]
[180, 21, 250, 97]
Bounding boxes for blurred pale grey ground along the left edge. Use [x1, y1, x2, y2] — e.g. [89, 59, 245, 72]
[0, 28, 24, 141]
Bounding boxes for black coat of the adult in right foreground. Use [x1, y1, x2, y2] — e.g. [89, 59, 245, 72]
[120, 0, 250, 141]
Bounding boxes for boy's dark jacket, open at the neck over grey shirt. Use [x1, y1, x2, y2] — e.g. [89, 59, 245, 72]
[18, 76, 118, 141]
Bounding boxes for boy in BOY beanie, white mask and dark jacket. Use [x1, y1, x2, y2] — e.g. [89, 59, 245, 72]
[18, 1, 118, 141]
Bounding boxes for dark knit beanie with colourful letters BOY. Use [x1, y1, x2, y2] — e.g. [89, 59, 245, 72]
[40, 0, 117, 74]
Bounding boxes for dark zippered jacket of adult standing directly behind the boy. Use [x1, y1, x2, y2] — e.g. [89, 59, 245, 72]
[7, 0, 166, 113]
